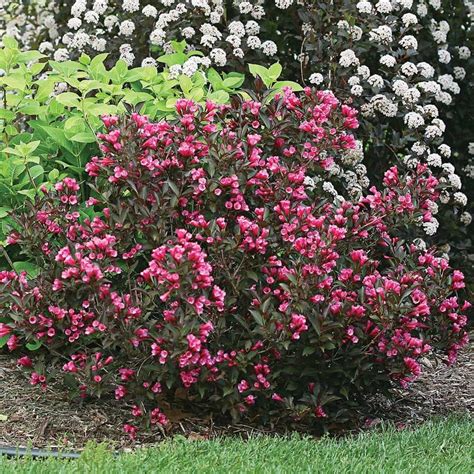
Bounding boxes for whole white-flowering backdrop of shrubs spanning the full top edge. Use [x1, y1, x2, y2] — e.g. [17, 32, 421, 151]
[2, 0, 474, 282]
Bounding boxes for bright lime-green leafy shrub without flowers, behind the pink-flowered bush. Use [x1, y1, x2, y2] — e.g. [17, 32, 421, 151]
[0, 37, 250, 246]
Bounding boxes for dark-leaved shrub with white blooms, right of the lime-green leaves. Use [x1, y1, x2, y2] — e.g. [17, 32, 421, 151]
[296, 0, 474, 288]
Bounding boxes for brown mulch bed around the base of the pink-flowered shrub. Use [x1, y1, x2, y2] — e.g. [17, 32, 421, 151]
[0, 345, 474, 450]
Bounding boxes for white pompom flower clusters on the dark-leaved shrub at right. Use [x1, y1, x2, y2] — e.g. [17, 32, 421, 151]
[306, 0, 474, 228]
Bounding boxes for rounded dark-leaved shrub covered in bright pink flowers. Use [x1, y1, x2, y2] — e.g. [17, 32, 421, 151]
[0, 89, 469, 437]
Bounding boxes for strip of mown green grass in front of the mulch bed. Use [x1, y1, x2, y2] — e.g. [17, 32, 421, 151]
[0, 419, 474, 474]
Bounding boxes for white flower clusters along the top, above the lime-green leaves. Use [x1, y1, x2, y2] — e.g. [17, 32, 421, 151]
[0, 0, 294, 67]
